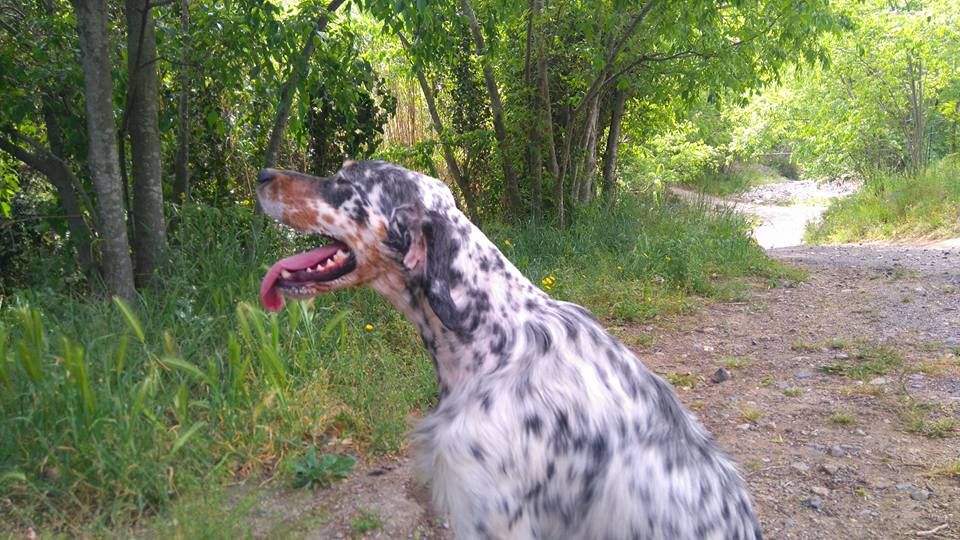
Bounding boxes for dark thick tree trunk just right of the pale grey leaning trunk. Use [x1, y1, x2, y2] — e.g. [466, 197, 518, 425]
[126, 0, 167, 285]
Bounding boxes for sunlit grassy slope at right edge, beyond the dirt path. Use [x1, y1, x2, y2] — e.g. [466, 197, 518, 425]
[807, 157, 960, 244]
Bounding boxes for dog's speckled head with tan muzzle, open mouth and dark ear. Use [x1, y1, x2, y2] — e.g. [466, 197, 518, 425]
[257, 162, 466, 324]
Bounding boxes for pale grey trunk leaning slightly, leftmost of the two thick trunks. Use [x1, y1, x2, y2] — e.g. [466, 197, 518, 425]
[72, 0, 136, 301]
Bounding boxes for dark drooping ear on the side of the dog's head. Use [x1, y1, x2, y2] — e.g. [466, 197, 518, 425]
[387, 206, 462, 332]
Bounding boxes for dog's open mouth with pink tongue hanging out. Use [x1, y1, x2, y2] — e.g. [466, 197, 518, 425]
[260, 239, 357, 311]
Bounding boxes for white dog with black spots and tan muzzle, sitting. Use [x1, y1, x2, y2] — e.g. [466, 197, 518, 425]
[257, 162, 761, 540]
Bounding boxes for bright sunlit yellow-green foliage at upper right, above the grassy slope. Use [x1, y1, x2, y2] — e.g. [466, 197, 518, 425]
[728, 0, 960, 176]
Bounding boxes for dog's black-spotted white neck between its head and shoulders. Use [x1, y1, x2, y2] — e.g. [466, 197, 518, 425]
[371, 220, 550, 398]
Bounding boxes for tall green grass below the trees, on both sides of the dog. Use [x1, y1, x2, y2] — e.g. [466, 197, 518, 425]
[0, 192, 784, 535]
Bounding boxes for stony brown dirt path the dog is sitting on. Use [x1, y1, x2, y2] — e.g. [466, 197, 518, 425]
[238, 184, 960, 539]
